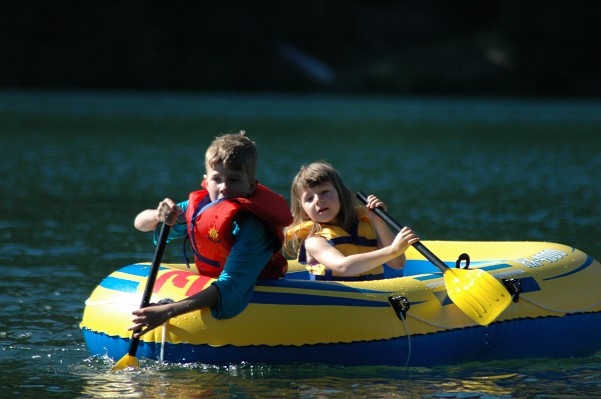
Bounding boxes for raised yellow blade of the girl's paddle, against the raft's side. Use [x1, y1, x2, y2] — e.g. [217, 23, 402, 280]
[444, 268, 511, 326]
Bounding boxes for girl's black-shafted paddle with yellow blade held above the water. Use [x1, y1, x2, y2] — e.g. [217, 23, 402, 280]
[357, 191, 511, 326]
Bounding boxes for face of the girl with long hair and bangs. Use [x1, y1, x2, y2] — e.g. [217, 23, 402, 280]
[301, 183, 340, 223]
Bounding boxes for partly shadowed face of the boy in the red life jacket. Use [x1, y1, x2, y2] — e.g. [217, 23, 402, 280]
[205, 162, 257, 201]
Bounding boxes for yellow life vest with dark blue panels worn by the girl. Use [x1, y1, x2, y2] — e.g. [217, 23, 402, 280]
[288, 216, 384, 281]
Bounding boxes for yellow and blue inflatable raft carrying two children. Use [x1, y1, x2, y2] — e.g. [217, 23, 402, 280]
[81, 241, 601, 366]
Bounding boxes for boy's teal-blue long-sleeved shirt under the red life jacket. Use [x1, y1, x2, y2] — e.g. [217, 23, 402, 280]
[154, 201, 273, 319]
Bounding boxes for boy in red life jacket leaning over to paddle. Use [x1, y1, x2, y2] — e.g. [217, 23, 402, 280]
[129, 131, 292, 337]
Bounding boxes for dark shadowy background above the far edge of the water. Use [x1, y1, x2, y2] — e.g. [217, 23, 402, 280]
[0, 0, 601, 98]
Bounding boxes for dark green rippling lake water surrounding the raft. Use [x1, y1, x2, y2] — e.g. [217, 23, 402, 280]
[0, 91, 601, 398]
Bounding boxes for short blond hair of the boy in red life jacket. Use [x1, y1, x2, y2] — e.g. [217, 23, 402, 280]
[205, 130, 259, 180]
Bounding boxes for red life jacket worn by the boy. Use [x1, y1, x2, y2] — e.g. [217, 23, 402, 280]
[186, 184, 292, 278]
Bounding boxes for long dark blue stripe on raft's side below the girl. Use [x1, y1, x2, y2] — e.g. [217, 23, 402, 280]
[251, 291, 390, 308]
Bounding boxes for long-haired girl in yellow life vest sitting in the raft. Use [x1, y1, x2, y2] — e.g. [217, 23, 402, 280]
[285, 162, 419, 281]
